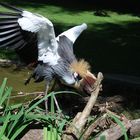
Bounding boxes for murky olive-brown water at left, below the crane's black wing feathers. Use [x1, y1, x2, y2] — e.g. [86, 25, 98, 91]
[0, 66, 45, 103]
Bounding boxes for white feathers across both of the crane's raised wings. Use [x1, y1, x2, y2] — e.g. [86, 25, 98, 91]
[18, 11, 87, 65]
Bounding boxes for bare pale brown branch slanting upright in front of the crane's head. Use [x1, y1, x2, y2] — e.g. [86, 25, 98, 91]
[62, 73, 103, 140]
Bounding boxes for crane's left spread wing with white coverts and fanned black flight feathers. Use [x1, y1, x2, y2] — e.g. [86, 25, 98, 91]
[0, 3, 57, 63]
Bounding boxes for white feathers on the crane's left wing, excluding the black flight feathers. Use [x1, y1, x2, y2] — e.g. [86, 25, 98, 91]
[18, 11, 58, 63]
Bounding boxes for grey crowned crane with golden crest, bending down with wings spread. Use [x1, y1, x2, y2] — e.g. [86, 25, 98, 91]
[0, 3, 96, 112]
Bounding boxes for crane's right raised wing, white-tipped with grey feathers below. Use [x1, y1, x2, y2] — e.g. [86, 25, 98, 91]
[56, 23, 87, 64]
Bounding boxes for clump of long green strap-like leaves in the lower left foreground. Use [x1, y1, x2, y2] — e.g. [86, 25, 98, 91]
[0, 78, 77, 140]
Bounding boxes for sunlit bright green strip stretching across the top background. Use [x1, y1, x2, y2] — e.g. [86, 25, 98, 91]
[0, 0, 140, 27]
